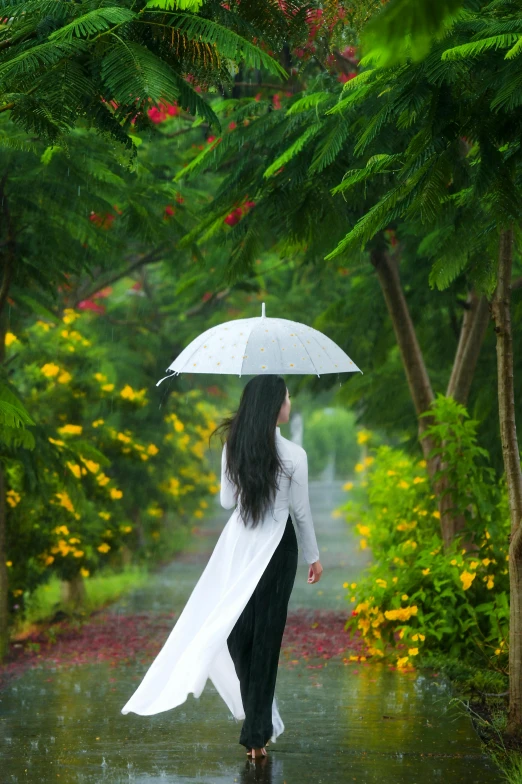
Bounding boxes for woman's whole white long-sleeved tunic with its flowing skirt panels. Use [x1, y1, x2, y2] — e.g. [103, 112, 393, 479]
[121, 427, 319, 741]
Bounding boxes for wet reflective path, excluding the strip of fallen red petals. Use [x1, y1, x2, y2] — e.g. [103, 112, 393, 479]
[0, 482, 504, 784]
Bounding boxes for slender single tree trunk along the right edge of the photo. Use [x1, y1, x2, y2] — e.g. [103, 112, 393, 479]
[491, 229, 522, 737]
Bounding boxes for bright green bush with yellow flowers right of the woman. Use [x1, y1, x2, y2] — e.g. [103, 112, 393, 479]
[341, 396, 509, 668]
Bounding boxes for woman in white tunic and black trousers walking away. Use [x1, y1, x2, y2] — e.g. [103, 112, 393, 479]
[122, 375, 322, 759]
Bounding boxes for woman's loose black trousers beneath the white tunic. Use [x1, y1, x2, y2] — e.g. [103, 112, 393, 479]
[227, 515, 298, 749]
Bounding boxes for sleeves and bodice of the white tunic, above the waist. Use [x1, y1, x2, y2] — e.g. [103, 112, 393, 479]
[220, 427, 319, 564]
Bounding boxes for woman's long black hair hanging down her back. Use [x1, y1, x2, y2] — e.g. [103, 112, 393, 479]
[211, 374, 292, 528]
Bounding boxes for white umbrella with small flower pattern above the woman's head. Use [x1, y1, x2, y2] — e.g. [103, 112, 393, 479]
[156, 302, 362, 386]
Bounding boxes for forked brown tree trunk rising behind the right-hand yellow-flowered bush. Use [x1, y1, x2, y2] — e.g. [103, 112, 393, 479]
[370, 248, 487, 550]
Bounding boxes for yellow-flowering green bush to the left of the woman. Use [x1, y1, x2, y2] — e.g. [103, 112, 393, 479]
[6, 309, 219, 611]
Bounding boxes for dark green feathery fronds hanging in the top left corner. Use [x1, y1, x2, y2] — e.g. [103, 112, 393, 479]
[0, 0, 294, 144]
